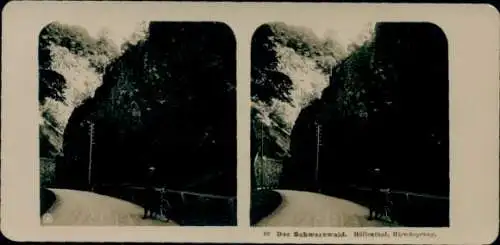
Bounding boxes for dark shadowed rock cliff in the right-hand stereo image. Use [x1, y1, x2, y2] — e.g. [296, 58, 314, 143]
[284, 23, 449, 195]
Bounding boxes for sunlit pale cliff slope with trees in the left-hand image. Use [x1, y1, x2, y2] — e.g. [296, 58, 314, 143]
[38, 22, 119, 185]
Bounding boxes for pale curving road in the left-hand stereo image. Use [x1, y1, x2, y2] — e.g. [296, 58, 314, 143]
[42, 189, 176, 226]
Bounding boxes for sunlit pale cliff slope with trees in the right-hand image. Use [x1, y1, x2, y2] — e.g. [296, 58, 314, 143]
[251, 22, 364, 189]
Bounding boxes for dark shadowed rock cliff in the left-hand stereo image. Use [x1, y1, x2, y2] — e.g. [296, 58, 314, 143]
[58, 22, 236, 192]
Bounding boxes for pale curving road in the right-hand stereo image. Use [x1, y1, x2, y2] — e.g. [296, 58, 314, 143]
[257, 190, 385, 227]
